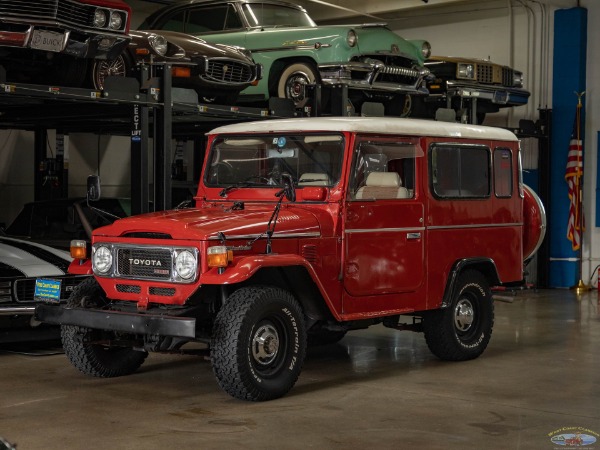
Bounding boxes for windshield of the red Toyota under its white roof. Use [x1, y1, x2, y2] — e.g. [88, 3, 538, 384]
[204, 134, 344, 189]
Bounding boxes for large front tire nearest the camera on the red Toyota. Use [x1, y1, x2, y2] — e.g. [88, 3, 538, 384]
[211, 286, 306, 401]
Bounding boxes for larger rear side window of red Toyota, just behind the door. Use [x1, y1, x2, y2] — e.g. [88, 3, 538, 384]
[429, 144, 490, 198]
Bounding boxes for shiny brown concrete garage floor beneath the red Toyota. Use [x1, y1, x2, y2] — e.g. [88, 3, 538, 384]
[0, 290, 600, 450]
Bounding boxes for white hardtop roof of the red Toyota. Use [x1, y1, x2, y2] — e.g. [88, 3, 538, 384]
[208, 117, 518, 141]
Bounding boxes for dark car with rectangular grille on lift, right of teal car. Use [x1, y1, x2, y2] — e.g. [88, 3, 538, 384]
[410, 56, 530, 123]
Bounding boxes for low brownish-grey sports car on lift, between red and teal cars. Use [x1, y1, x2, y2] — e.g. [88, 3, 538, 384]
[90, 30, 261, 104]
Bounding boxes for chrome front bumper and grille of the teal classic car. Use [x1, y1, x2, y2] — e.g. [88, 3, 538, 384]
[319, 61, 429, 94]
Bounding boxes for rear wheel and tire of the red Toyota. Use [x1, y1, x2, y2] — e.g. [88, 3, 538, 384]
[423, 270, 494, 361]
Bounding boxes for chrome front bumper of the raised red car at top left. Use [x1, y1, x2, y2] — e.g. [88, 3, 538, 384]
[0, 22, 129, 59]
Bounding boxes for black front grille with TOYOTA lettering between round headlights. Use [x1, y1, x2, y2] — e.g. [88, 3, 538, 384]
[117, 248, 172, 280]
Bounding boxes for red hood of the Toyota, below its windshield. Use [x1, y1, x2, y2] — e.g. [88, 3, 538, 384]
[94, 204, 320, 241]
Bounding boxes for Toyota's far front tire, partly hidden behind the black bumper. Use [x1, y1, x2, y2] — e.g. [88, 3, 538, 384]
[60, 278, 148, 378]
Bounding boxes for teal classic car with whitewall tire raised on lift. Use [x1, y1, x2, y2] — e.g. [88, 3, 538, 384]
[140, 0, 431, 109]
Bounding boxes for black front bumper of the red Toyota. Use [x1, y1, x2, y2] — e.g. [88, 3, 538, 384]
[35, 304, 196, 339]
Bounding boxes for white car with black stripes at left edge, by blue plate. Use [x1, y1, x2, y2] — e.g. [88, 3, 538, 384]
[0, 230, 86, 342]
